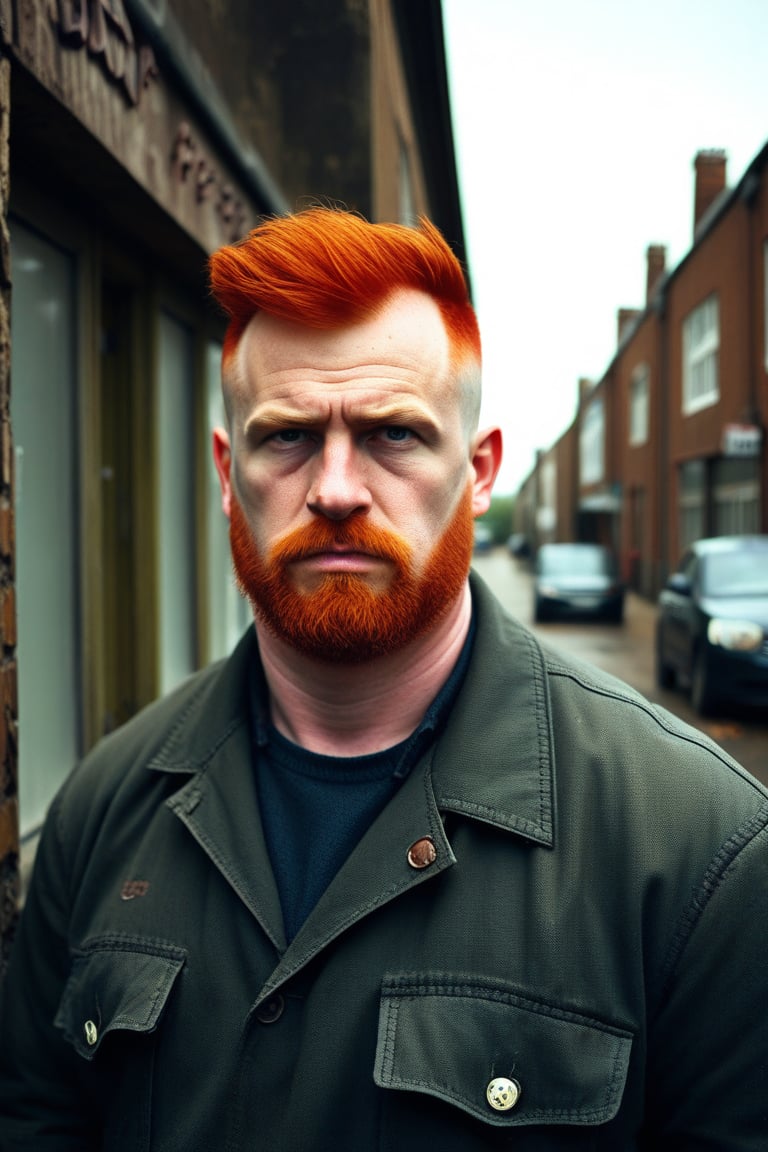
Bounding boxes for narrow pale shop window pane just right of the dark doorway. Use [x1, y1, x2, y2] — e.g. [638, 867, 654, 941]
[158, 312, 197, 695]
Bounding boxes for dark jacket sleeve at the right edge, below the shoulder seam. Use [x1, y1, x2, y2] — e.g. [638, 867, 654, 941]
[642, 806, 768, 1152]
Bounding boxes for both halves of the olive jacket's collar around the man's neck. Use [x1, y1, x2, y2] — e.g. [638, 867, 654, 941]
[149, 573, 555, 846]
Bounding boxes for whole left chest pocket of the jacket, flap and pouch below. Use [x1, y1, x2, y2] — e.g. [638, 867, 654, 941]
[54, 937, 185, 1150]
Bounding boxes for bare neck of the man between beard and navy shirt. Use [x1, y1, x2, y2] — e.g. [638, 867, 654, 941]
[256, 584, 472, 756]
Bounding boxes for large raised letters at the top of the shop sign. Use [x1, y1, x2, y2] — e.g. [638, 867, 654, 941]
[51, 0, 158, 107]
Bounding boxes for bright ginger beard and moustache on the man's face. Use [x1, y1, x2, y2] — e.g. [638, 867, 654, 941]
[229, 486, 473, 664]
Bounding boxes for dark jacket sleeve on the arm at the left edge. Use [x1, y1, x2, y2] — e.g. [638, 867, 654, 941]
[0, 794, 100, 1152]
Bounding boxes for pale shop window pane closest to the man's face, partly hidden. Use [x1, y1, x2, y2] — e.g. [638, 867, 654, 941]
[206, 342, 252, 660]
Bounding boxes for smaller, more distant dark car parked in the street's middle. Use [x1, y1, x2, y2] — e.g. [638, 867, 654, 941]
[533, 544, 624, 623]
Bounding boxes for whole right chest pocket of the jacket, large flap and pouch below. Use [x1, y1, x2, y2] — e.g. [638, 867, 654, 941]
[374, 976, 632, 1150]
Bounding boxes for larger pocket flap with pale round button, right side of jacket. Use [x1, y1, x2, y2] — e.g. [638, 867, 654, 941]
[374, 976, 632, 1127]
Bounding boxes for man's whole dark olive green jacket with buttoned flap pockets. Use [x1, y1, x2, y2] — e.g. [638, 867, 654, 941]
[0, 577, 768, 1152]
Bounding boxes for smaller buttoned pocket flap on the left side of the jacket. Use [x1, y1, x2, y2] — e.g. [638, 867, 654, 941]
[54, 937, 184, 1060]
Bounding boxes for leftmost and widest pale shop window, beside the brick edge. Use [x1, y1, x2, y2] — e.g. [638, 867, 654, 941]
[10, 221, 82, 835]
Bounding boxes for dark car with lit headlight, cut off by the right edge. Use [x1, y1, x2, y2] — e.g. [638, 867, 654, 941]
[656, 536, 768, 715]
